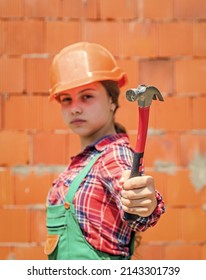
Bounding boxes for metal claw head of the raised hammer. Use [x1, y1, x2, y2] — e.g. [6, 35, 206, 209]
[126, 85, 164, 107]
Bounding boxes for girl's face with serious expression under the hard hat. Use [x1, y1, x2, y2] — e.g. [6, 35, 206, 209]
[59, 82, 115, 141]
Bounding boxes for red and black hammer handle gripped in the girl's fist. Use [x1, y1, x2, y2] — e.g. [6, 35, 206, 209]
[123, 107, 150, 222]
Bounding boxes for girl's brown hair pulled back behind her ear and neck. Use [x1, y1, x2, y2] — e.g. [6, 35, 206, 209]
[101, 80, 127, 134]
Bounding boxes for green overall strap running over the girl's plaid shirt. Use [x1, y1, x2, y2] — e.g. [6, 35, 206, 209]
[65, 153, 101, 203]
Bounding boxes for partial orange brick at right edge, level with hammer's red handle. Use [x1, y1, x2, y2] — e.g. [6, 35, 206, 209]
[191, 97, 206, 129]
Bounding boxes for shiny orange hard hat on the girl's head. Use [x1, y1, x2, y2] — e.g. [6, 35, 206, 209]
[50, 42, 127, 99]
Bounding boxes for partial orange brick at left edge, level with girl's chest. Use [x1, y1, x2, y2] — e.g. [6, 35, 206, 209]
[0, 168, 14, 205]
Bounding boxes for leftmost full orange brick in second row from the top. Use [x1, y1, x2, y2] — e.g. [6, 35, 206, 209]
[5, 20, 44, 55]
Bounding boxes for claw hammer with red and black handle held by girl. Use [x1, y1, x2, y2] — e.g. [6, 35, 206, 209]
[123, 85, 164, 221]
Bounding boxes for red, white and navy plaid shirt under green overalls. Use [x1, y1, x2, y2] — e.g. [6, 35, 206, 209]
[48, 134, 164, 256]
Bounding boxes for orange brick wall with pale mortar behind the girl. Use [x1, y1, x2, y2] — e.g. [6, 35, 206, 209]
[0, 0, 206, 259]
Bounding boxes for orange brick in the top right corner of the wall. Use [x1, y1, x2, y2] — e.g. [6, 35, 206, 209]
[173, 0, 206, 20]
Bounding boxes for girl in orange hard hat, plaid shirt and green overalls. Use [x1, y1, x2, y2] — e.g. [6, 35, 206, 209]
[45, 42, 164, 260]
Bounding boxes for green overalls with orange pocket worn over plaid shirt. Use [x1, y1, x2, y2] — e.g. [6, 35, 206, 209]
[44, 154, 134, 260]
